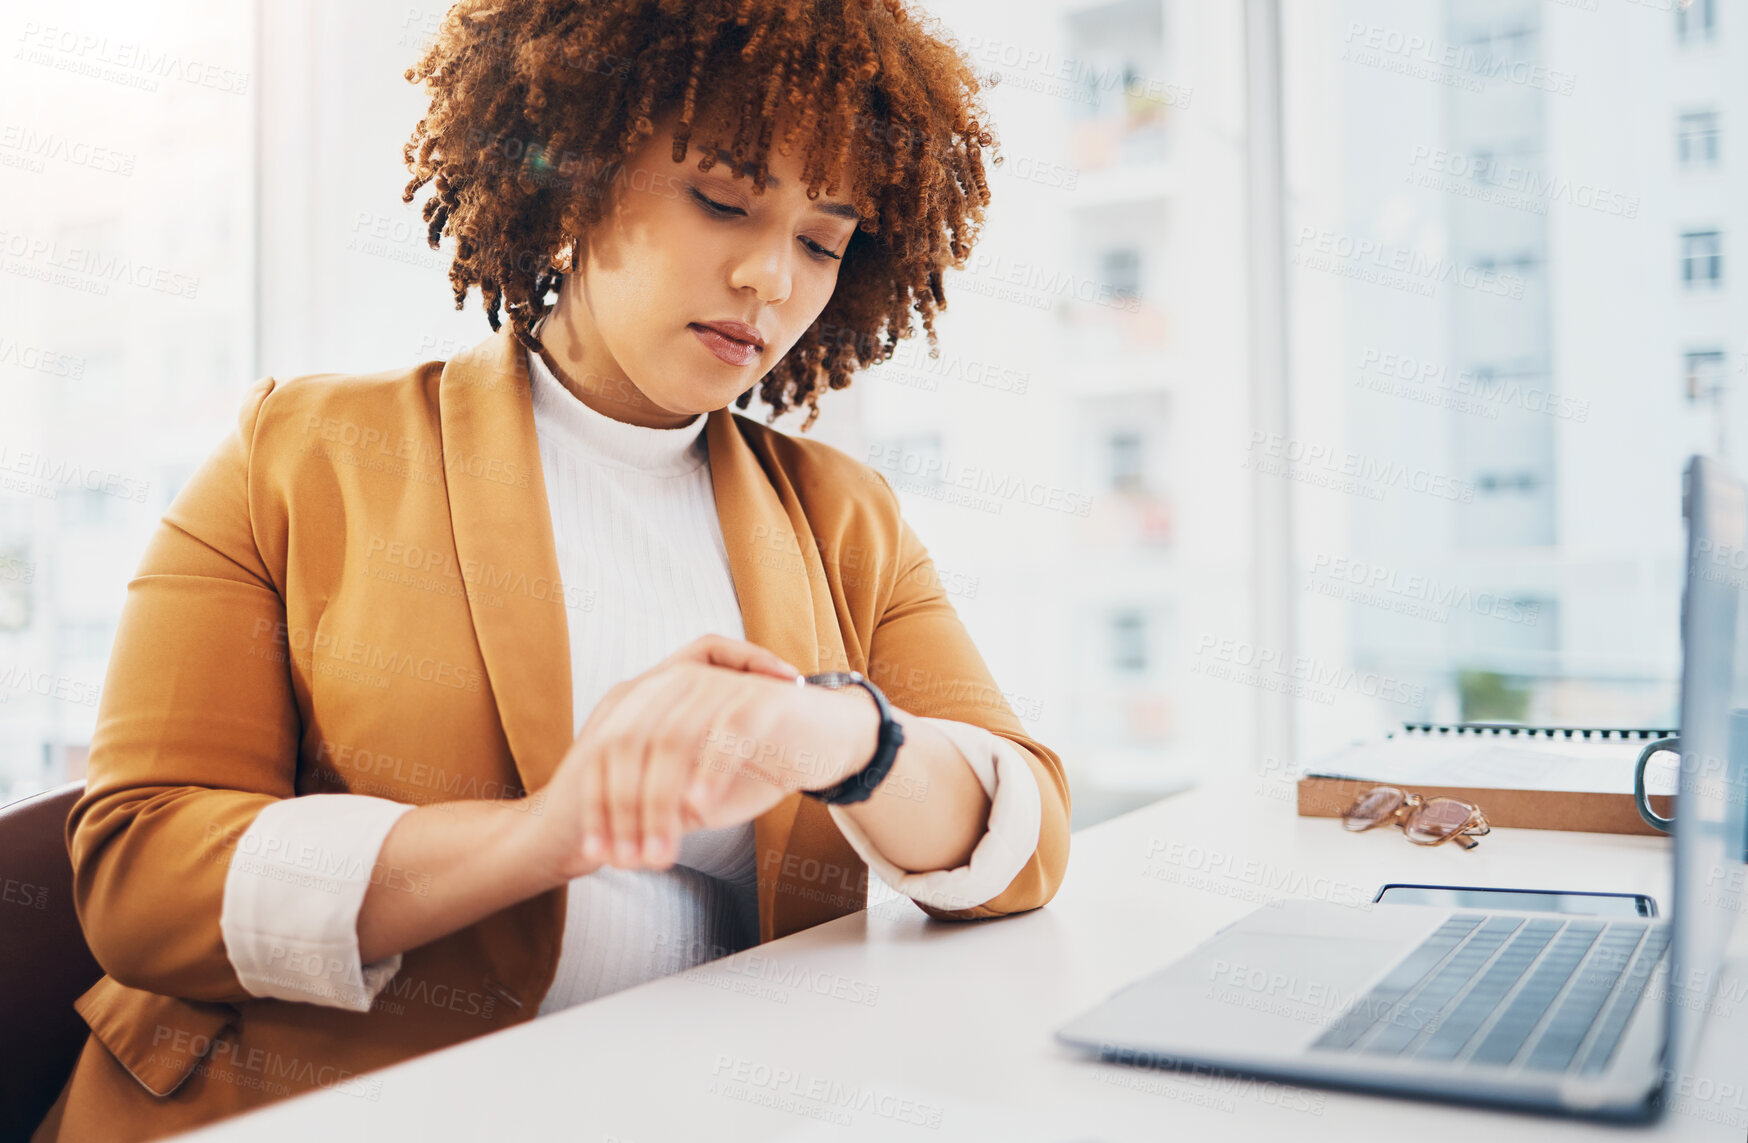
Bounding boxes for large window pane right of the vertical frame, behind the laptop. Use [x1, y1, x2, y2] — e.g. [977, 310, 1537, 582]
[1286, 0, 1706, 764]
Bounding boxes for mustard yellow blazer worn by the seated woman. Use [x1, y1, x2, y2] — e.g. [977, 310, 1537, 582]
[35, 325, 1070, 1140]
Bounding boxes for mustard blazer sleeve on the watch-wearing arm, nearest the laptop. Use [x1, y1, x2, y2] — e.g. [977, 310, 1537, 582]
[867, 468, 1072, 921]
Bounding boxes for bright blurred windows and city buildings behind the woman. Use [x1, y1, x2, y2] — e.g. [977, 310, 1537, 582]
[0, 0, 1748, 828]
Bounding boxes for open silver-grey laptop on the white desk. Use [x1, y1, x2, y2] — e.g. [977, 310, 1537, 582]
[1056, 456, 1748, 1120]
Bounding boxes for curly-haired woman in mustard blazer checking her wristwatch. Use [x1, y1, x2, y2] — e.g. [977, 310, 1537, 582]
[37, 0, 1070, 1140]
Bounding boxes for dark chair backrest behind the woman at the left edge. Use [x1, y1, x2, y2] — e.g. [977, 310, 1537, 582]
[0, 781, 103, 1140]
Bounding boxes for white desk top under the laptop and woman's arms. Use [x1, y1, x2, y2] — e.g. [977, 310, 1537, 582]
[166, 779, 1748, 1143]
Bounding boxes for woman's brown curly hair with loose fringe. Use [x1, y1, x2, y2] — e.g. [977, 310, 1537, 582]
[402, 0, 1002, 430]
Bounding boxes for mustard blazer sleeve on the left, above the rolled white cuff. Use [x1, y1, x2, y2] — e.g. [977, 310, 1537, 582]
[66, 378, 301, 1001]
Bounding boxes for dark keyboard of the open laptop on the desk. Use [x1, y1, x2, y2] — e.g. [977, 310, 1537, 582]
[1311, 914, 1669, 1075]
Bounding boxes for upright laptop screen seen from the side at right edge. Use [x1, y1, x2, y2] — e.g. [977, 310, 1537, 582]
[1666, 456, 1748, 1075]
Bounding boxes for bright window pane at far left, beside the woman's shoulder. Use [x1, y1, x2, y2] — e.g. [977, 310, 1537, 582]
[0, 0, 255, 802]
